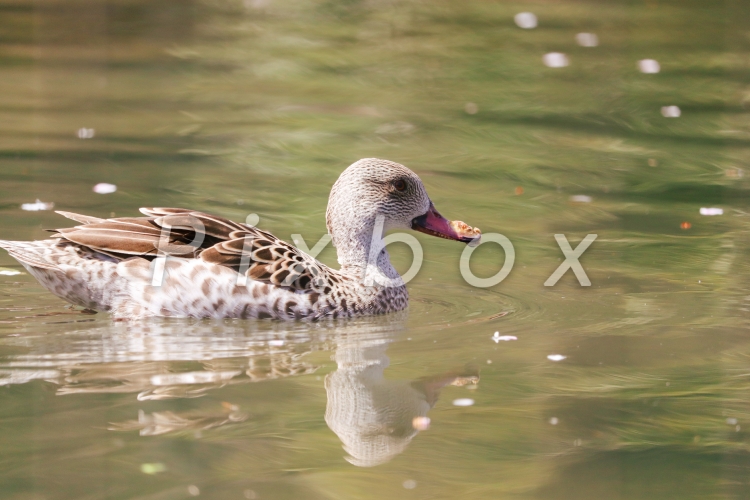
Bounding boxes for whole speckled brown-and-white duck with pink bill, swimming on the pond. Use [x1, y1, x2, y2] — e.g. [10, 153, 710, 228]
[0, 158, 481, 320]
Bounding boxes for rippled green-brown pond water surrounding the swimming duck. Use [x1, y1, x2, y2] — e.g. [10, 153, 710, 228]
[0, 0, 750, 500]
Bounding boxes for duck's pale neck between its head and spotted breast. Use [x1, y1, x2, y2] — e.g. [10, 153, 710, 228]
[331, 216, 401, 286]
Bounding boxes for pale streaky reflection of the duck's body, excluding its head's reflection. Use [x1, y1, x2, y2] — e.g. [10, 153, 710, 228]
[0, 321, 319, 401]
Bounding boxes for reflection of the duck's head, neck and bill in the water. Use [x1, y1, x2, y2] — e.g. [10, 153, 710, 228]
[325, 335, 479, 467]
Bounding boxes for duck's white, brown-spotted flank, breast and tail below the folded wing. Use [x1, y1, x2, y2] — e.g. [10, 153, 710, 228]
[0, 221, 408, 319]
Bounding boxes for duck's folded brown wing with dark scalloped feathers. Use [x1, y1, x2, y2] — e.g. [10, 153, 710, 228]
[53, 207, 337, 290]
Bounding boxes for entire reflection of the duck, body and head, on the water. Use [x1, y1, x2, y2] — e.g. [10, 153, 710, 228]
[0, 314, 479, 466]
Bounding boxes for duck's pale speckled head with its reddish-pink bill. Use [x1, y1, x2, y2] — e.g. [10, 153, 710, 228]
[326, 158, 481, 264]
